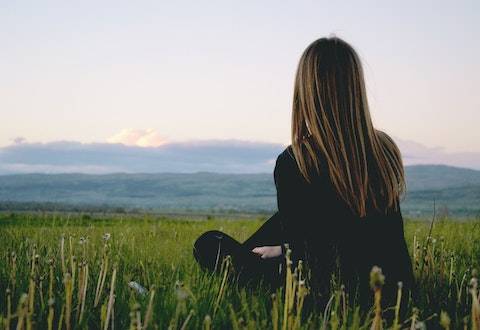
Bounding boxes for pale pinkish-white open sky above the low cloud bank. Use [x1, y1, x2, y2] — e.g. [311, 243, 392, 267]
[0, 0, 480, 152]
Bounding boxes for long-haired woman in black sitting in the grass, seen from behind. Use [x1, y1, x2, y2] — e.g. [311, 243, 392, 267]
[194, 37, 413, 310]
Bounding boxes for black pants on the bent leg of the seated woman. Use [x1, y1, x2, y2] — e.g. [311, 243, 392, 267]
[193, 213, 285, 288]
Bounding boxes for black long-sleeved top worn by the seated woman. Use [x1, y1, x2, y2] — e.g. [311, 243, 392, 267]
[274, 147, 413, 306]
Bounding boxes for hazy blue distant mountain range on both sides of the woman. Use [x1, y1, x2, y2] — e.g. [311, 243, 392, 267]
[0, 165, 480, 216]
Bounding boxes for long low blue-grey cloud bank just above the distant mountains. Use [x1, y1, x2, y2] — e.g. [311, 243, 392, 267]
[0, 136, 480, 174]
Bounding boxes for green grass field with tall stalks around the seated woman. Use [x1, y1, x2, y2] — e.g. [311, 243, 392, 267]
[0, 214, 480, 329]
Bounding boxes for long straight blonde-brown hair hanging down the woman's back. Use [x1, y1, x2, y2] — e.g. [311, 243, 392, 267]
[292, 37, 405, 217]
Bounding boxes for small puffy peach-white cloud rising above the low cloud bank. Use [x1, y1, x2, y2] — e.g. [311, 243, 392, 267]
[107, 128, 167, 147]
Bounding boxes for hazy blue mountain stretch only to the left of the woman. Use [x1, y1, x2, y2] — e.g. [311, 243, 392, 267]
[0, 173, 275, 213]
